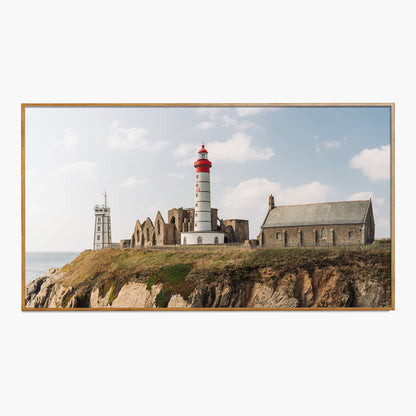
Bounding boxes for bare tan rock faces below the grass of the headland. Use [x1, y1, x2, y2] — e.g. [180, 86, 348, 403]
[26, 267, 387, 309]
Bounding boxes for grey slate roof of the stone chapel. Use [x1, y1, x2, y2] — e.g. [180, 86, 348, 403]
[262, 200, 371, 228]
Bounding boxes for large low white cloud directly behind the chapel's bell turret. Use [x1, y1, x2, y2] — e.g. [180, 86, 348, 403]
[220, 178, 332, 237]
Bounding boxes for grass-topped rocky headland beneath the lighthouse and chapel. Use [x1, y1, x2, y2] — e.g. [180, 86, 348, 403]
[26, 249, 391, 309]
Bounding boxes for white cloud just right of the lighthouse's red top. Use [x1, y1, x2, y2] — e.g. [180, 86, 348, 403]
[207, 132, 274, 163]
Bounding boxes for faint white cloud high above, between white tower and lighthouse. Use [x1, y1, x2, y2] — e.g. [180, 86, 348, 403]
[107, 121, 170, 150]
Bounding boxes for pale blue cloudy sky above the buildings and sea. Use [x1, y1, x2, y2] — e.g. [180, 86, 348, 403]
[25, 107, 390, 251]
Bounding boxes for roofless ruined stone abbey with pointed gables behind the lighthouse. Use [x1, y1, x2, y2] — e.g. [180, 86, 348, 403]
[120, 208, 249, 248]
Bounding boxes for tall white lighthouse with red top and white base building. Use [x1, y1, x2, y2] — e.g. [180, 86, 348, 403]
[181, 145, 224, 245]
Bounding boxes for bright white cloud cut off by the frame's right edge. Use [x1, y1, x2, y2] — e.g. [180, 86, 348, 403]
[350, 145, 390, 182]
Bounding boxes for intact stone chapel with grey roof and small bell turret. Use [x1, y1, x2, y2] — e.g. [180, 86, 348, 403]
[258, 195, 375, 247]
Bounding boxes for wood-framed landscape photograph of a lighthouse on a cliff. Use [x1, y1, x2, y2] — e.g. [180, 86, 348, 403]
[21, 103, 395, 311]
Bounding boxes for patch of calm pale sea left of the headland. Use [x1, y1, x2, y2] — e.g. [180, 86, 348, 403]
[25, 251, 80, 283]
